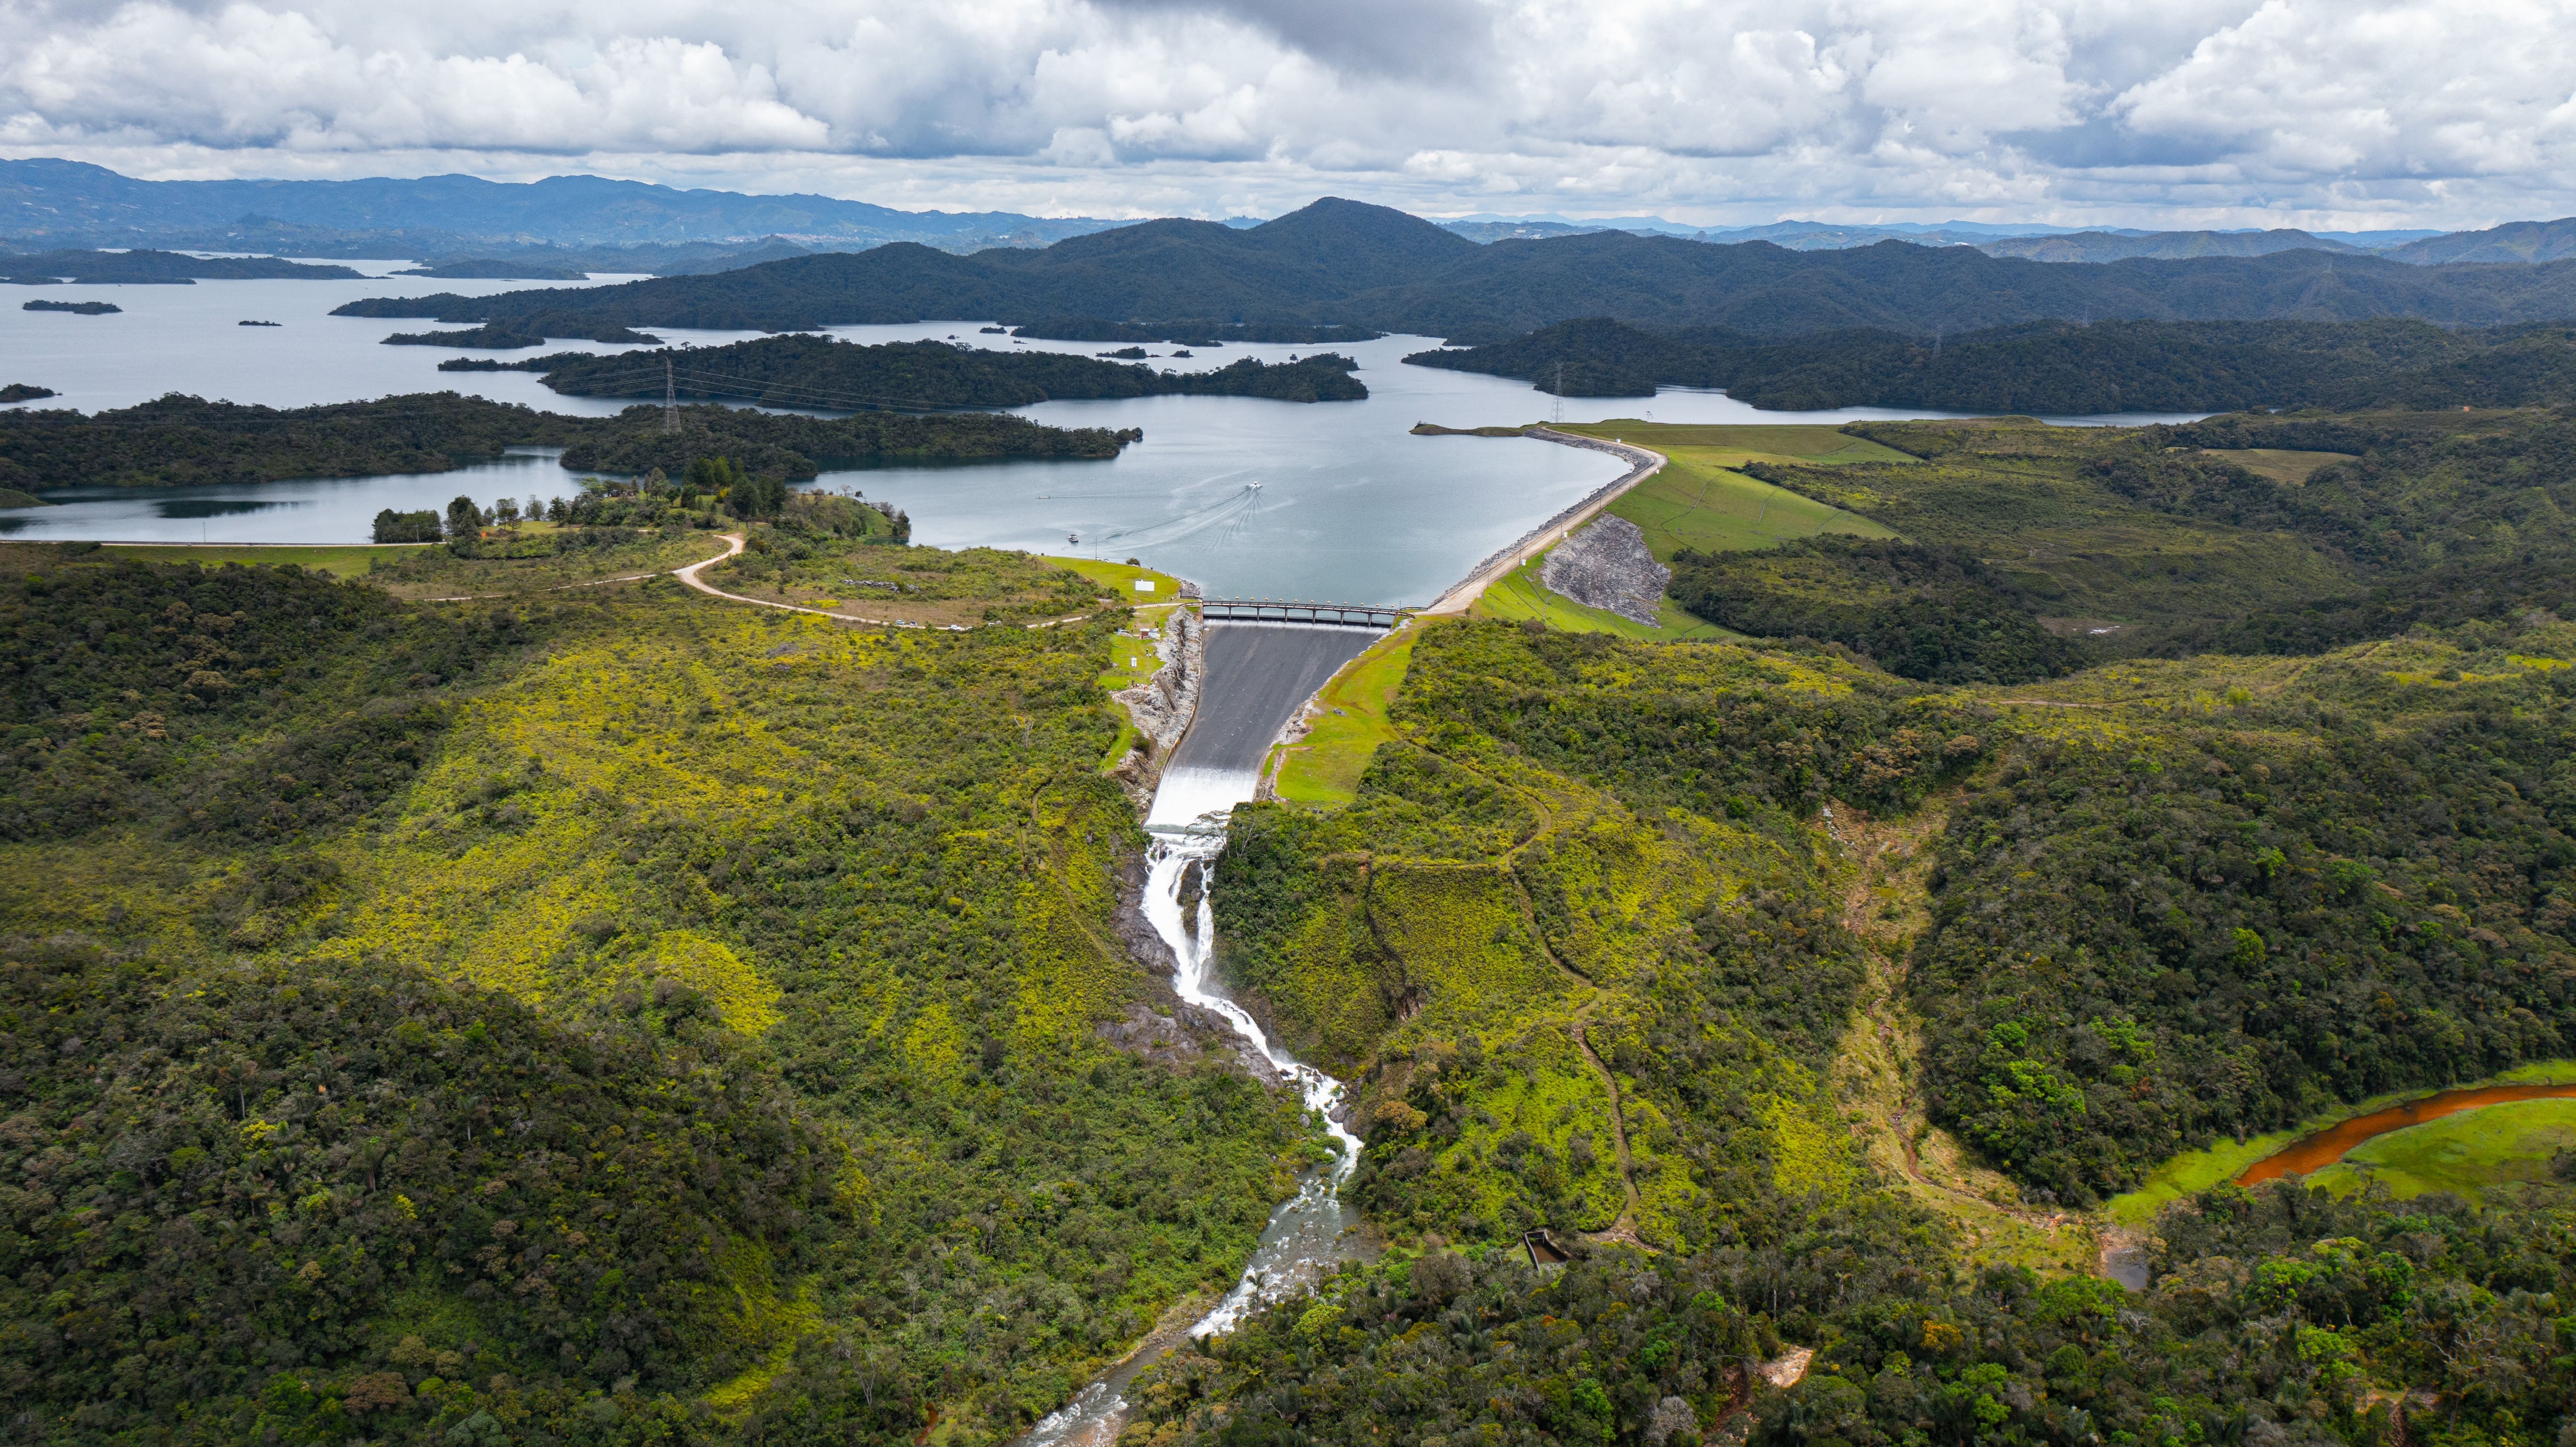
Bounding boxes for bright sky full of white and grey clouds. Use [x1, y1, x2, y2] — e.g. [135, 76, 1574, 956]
[0, 0, 2576, 227]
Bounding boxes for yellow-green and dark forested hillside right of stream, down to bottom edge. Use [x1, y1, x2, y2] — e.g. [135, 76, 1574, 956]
[1154, 608, 2576, 1445]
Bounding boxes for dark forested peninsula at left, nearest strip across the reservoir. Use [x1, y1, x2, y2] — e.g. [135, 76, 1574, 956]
[0, 391, 1141, 492]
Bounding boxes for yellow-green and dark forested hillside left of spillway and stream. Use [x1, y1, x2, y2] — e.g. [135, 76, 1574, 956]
[0, 523, 1311, 1442]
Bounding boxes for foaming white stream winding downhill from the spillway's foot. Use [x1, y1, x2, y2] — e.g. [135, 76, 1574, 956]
[1015, 770, 1362, 1447]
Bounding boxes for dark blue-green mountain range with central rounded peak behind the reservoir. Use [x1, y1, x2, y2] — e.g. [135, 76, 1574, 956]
[327, 198, 2576, 343]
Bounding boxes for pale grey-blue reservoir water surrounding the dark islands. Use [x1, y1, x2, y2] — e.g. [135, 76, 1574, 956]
[0, 263, 2169, 605]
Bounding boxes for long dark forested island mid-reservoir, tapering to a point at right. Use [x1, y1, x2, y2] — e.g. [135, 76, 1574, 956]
[440, 337, 1368, 410]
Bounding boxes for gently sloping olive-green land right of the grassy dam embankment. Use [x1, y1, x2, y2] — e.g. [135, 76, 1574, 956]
[1675, 410, 2576, 656]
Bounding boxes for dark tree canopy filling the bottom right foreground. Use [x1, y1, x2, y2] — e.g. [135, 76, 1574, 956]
[1123, 1159, 2576, 1447]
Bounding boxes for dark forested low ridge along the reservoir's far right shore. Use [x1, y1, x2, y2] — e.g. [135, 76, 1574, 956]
[1404, 319, 2576, 414]
